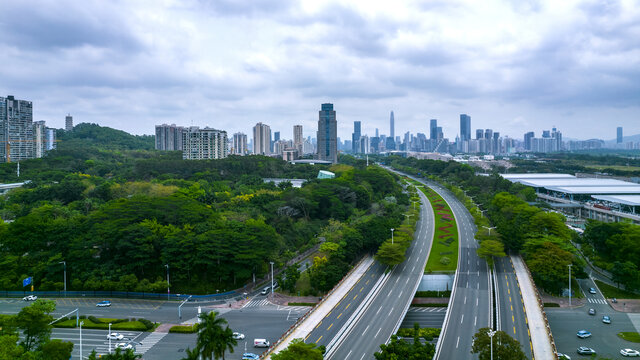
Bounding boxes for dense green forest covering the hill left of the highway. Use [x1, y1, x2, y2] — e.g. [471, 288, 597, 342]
[0, 124, 409, 294]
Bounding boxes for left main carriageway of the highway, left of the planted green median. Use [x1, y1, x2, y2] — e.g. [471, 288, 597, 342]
[325, 180, 434, 360]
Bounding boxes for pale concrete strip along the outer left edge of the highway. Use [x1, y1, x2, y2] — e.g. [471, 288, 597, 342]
[266, 256, 373, 359]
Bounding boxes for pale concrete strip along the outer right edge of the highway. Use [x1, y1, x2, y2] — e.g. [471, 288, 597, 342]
[511, 255, 555, 359]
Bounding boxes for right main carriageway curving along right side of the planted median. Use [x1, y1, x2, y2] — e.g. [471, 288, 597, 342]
[411, 177, 491, 360]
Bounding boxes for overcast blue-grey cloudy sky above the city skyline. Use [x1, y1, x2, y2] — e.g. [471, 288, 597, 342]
[0, 0, 640, 139]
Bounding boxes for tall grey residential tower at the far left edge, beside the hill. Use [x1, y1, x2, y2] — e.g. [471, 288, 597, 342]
[0, 95, 33, 162]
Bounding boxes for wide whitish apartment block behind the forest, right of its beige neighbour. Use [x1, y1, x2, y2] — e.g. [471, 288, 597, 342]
[182, 126, 229, 160]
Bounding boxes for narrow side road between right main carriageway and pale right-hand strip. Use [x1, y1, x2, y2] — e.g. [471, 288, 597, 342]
[495, 257, 533, 359]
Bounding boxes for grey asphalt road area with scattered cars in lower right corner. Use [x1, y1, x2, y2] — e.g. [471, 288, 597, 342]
[545, 279, 640, 359]
